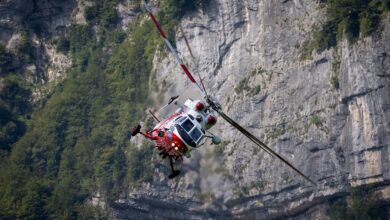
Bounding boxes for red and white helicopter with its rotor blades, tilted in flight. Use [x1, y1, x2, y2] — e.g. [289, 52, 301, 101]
[131, 1, 316, 185]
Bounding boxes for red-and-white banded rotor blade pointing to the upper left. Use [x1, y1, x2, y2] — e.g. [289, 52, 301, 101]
[144, 0, 206, 97]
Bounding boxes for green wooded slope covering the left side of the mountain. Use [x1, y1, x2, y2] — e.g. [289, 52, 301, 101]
[0, 0, 201, 219]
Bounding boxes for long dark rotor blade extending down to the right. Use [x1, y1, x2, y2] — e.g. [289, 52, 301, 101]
[214, 108, 317, 185]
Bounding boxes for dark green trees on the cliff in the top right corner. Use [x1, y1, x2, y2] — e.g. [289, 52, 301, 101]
[300, 0, 389, 60]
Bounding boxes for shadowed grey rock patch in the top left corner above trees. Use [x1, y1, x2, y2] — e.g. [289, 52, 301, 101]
[0, 0, 74, 84]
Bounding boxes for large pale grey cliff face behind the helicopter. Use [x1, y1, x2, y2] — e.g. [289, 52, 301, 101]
[112, 0, 390, 219]
